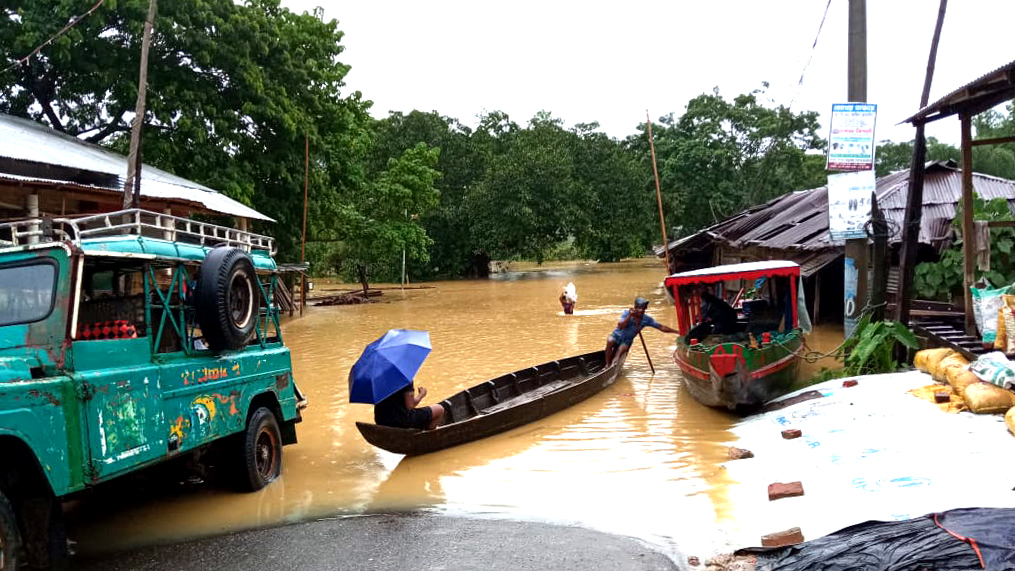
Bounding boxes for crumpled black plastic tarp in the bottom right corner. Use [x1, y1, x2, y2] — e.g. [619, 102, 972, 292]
[737, 508, 1015, 571]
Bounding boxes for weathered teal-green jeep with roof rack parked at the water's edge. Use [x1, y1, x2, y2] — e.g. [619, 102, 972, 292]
[0, 210, 306, 571]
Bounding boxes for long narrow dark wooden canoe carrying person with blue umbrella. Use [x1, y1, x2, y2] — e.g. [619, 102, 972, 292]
[356, 351, 623, 455]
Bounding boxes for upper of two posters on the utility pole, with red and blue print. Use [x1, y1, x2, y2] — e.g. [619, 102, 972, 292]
[825, 103, 878, 170]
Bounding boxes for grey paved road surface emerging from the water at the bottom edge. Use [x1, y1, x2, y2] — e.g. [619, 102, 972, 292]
[75, 514, 678, 571]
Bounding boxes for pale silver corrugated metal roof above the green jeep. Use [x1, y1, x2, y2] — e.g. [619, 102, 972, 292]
[0, 114, 274, 222]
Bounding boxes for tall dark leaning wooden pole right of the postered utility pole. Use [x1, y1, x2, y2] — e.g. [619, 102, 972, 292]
[896, 0, 948, 325]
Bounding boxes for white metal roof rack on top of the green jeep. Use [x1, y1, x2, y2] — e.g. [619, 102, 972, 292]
[0, 208, 276, 256]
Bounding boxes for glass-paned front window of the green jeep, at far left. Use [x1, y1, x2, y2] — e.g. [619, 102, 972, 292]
[0, 262, 57, 327]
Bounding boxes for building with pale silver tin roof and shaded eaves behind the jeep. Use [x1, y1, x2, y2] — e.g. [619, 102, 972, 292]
[0, 114, 273, 226]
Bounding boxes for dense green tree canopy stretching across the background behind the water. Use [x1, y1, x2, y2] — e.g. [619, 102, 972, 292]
[11, 0, 1002, 283]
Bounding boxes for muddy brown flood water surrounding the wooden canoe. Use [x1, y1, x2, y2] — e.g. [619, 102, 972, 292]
[63, 260, 841, 555]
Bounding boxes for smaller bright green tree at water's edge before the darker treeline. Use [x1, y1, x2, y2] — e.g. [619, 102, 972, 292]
[334, 143, 441, 294]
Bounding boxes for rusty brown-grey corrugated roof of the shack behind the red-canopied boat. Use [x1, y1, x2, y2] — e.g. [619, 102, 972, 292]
[660, 161, 1015, 259]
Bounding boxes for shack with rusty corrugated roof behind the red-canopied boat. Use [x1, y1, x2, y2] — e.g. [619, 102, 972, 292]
[657, 161, 1015, 323]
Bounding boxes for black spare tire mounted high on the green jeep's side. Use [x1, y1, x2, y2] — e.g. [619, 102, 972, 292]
[194, 246, 261, 351]
